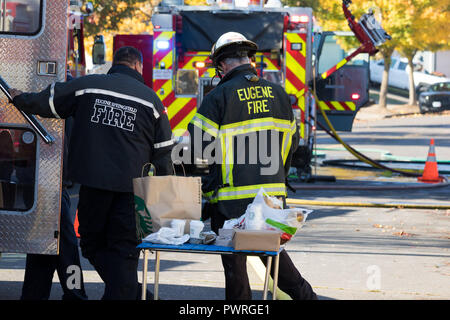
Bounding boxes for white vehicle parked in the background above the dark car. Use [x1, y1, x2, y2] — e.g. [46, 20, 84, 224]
[370, 58, 450, 90]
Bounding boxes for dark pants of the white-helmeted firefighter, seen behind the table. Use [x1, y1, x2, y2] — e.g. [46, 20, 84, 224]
[211, 207, 317, 300]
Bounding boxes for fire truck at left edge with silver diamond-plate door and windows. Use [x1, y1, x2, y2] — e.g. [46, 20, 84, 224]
[0, 0, 92, 254]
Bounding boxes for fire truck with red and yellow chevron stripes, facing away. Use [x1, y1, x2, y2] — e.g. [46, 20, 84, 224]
[113, 0, 369, 176]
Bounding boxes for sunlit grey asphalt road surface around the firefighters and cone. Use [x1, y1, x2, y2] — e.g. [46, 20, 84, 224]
[0, 109, 450, 300]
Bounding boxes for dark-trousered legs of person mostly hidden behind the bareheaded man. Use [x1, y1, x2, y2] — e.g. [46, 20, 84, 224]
[21, 189, 87, 300]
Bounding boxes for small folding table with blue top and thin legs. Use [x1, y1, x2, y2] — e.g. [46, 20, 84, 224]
[137, 242, 282, 300]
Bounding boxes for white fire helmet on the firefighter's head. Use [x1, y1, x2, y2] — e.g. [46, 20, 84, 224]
[210, 32, 258, 67]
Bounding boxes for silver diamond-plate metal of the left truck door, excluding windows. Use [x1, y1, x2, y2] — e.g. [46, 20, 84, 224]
[0, 0, 68, 254]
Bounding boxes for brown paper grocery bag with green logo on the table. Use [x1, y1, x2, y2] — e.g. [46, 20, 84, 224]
[133, 170, 202, 239]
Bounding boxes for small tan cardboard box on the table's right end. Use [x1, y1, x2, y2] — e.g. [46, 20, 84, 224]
[233, 229, 280, 251]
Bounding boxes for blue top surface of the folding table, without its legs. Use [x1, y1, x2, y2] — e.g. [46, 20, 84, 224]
[137, 242, 283, 256]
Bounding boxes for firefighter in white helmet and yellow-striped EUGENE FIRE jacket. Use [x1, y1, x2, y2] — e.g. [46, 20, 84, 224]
[188, 32, 317, 300]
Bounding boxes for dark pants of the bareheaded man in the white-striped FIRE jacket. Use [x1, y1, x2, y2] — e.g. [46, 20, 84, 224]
[78, 186, 144, 300]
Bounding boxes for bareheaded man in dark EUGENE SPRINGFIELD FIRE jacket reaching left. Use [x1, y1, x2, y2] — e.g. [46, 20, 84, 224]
[11, 47, 174, 300]
